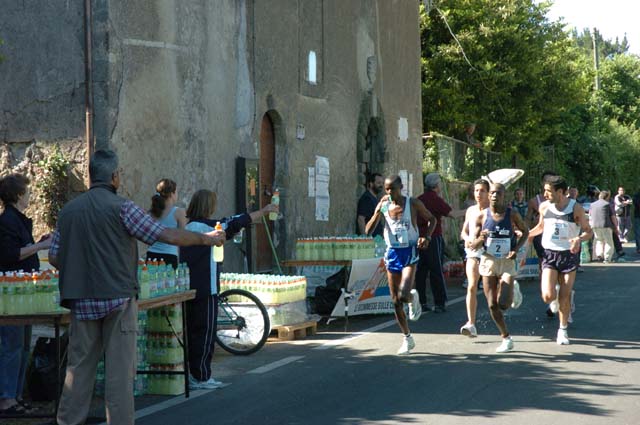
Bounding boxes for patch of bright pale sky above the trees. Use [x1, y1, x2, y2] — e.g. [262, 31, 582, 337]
[547, 0, 640, 55]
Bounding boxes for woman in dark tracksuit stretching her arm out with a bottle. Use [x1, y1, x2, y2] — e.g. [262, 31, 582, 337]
[180, 190, 278, 389]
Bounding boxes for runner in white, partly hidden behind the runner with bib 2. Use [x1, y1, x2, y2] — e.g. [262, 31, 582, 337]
[460, 179, 489, 338]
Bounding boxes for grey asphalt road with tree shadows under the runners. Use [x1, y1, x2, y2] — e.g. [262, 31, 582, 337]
[136, 249, 640, 425]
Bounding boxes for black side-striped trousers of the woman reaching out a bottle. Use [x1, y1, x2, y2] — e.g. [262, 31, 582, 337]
[187, 295, 218, 381]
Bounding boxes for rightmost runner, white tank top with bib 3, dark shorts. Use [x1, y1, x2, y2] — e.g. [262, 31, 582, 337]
[529, 176, 592, 345]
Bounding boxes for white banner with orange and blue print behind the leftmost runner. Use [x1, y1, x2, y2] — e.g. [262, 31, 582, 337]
[331, 258, 394, 317]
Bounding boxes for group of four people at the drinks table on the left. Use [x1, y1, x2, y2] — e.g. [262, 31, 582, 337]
[0, 150, 278, 425]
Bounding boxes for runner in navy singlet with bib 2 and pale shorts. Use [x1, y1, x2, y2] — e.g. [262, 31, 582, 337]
[471, 183, 529, 353]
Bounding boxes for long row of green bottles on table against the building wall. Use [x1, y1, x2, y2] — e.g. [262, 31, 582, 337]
[296, 235, 378, 261]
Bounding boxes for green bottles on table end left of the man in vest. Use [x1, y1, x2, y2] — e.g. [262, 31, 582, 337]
[0, 270, 68, 315]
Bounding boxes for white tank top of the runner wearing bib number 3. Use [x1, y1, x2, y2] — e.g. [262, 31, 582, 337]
[542, 199, 580, 251]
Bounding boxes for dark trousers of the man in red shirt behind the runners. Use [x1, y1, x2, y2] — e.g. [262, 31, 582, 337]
[416, 236, 448, 307]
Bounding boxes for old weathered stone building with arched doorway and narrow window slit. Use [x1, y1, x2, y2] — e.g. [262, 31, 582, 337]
[0, 0, 422, 270]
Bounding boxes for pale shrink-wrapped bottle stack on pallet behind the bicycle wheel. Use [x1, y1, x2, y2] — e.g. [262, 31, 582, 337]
[220, 273, 308, 326]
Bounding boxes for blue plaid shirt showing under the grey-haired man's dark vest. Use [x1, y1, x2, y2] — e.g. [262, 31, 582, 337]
[49, 201, 165, 320]
